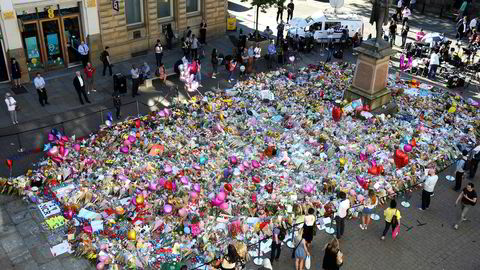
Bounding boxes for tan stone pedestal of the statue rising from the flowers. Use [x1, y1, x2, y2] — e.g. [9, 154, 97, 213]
[344, 39, 395, 111]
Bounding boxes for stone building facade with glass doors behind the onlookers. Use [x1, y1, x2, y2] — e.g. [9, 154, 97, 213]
[0, 0, 227, 82]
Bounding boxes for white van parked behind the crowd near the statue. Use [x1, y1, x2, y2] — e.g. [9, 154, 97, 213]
[287, 12, 364, 43]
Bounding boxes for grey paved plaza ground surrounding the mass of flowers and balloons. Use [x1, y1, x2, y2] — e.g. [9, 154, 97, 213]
[0, 0, 480, 270]
